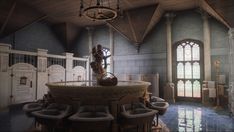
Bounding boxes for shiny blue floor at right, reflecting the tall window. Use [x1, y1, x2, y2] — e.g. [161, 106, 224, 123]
[160, 102, 234, 132]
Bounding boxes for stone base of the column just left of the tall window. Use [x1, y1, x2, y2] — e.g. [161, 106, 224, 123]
[164, 82, 175, 103]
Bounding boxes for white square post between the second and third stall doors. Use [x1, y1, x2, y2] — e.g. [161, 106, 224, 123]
[64, 52, 73, 81]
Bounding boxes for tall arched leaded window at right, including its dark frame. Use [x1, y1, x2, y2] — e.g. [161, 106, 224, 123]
[173, 39, 203, 99]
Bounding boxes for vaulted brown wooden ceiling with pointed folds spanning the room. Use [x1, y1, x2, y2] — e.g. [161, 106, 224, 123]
[0, 0, 234, 49]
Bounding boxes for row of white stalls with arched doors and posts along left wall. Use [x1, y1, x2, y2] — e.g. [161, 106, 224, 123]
[0, 43, 89, 108]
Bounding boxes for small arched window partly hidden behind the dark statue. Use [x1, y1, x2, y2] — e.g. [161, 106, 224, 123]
[102, 47, 111, 72]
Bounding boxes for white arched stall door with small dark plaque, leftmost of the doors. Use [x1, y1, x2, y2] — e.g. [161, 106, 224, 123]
[9, 63, 36, 104]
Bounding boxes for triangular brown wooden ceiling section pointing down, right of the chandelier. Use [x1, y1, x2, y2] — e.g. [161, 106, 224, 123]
[108, 5, 157, 45]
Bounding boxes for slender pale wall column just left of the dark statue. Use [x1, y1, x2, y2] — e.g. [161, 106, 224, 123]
[86, 27, 93, 80]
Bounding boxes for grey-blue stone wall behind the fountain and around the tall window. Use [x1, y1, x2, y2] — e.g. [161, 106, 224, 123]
[74, 10, 229, 95]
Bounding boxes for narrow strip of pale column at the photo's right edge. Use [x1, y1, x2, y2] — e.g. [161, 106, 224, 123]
[228, 28, 234, 114]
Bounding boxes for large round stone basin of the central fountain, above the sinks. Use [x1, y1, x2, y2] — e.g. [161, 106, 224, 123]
[46, 81, 150, 100]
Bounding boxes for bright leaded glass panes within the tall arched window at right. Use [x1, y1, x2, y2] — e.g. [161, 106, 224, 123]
[176, 40, 201, 99]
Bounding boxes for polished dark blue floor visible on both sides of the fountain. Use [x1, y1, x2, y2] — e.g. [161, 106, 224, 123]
[0, 102, 234, 132]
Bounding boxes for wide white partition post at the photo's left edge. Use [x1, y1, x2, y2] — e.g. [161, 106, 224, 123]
[0, 43, 11, 108]
